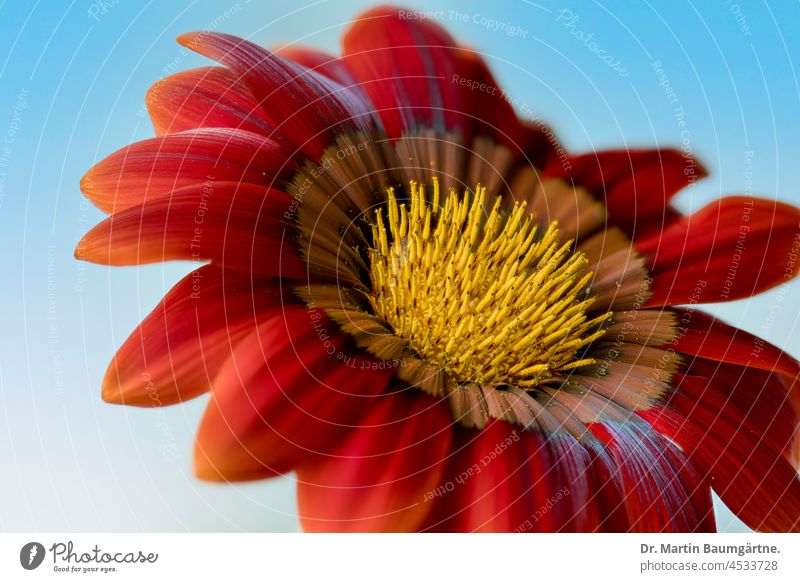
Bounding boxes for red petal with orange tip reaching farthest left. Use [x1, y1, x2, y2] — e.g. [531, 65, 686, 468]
[75, 182, 306, 278]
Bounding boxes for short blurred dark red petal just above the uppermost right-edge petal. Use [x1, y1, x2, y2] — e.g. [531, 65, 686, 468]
[546, 149, 706, 237]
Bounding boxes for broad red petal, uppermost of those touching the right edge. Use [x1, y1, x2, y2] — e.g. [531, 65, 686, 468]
[635, 196, 800, 306]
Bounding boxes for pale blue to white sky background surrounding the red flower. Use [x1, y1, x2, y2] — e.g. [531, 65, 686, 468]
[0, 0, 800, 531]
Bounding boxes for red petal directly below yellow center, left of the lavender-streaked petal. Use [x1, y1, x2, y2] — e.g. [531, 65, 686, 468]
[424, 421, 600, 532]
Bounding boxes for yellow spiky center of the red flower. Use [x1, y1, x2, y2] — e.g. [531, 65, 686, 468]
[369, 178, 611, 387]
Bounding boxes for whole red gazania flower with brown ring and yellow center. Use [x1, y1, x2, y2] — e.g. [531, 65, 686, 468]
[77, 8, 800, 531]
